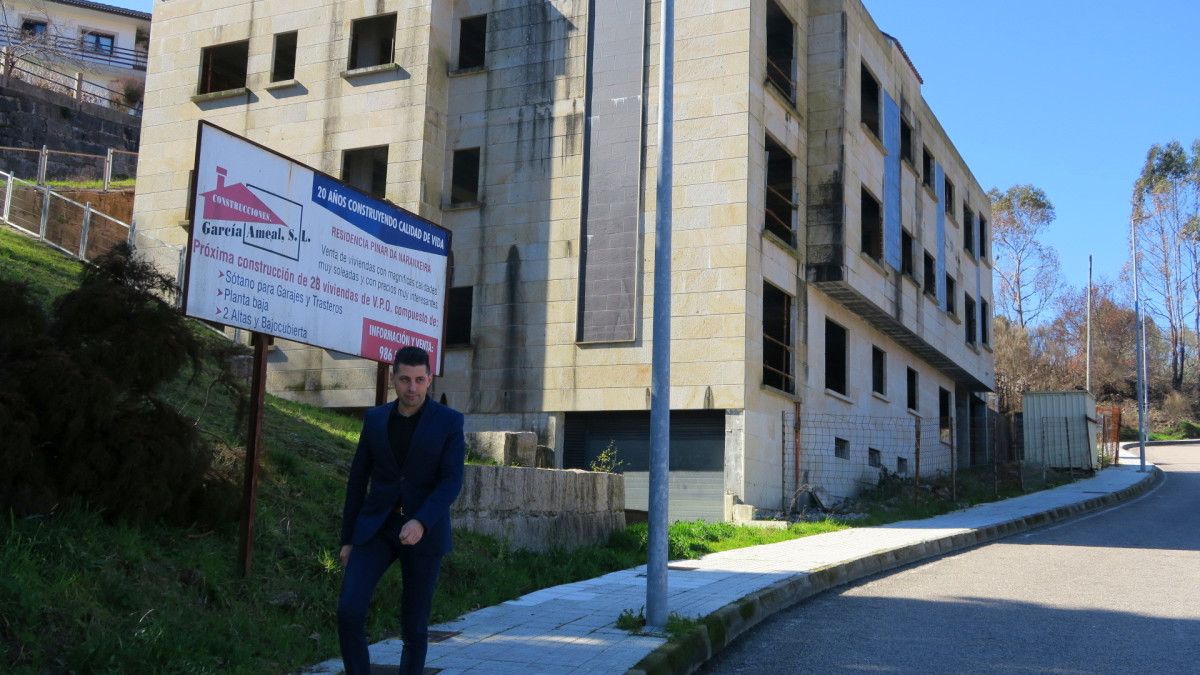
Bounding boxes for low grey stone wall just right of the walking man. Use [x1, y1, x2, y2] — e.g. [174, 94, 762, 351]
[450, 465, 625, 551]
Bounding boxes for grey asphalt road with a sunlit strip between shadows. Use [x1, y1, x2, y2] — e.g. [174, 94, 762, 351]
[702, 446, 1200, 674]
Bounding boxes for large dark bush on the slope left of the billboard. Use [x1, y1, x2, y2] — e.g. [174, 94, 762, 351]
[0, 245, 236, 524]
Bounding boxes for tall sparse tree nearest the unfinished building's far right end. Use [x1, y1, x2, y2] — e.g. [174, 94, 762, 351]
[988, 185, 1062, 328]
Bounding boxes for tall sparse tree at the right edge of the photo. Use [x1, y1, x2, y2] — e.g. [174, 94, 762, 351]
[1130, 141, 1200, 390]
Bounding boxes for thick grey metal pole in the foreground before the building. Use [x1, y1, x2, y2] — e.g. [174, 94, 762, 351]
[646, 0, 674, 629]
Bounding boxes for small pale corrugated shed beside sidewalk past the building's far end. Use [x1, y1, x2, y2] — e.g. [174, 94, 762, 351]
[1021, 390, 1100, 470]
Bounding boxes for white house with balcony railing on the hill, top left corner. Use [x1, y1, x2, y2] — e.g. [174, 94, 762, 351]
[0, 0, 150, 109]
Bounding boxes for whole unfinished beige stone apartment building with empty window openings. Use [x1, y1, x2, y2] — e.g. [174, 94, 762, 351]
[134, 0, 994, 520]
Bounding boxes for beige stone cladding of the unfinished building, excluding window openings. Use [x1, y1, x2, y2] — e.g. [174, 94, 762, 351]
[134, 0, 992, 518]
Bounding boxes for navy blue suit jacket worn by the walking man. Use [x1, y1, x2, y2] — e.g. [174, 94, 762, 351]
[342, 399, 466, 555]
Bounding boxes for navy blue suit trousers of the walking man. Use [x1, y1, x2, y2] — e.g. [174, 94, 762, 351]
[337, 515, 442, 675]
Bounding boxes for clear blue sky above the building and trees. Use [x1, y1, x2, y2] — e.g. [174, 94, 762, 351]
[109, 0, 1200, 286]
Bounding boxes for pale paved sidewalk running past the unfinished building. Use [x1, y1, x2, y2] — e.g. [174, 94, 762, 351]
[307, 454, 1157, 675]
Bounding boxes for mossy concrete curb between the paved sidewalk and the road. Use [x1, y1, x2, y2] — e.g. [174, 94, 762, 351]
[626, 466, 1160, 675]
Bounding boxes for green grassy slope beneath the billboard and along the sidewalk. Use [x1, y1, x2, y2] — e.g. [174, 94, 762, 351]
[0, 227, 842, 673]
